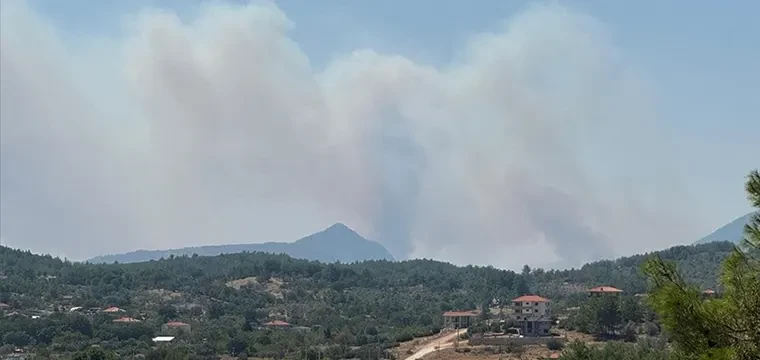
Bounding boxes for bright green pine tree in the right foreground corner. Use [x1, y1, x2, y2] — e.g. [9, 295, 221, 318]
[644, 170, 760, 360]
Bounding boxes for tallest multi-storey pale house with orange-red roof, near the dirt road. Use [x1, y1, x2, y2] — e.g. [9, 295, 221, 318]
[511, 294, 552, 336]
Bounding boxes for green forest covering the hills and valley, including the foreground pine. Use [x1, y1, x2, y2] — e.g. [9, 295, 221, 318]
[0, 172, 760, 359]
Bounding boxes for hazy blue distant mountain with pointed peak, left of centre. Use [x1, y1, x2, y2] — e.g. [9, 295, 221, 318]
[87, 223, 394, 263]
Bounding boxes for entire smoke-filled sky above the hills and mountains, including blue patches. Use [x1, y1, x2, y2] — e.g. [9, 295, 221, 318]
[0, 0, 760, 269]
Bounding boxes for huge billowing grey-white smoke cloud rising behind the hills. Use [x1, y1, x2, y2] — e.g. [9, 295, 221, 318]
[0, 2, 697, 268]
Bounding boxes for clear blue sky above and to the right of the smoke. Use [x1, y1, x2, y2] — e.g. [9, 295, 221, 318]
[3, 0, 760, 266]
